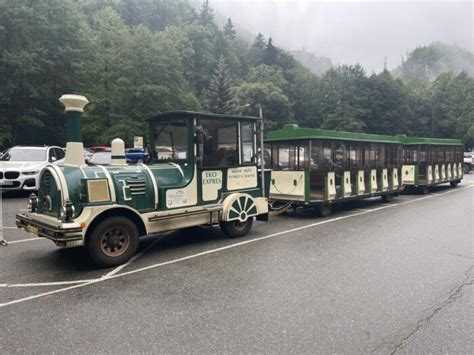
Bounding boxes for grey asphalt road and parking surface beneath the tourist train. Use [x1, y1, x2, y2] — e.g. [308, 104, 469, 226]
[0, 176, 474, 353]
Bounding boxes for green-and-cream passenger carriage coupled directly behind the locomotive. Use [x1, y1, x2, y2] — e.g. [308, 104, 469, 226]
[265, 124, 402, 215]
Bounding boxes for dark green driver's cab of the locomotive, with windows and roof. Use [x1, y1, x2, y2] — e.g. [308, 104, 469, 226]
[148, 111, 264, 209]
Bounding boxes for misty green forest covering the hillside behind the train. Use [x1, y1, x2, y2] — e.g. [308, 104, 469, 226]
[0, 0, 474, 150]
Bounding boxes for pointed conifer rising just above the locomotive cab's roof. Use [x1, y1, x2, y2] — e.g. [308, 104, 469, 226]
[206, 56, 233, 113]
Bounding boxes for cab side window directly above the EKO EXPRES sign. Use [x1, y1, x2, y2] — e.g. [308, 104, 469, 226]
[196, 119, 239, 168]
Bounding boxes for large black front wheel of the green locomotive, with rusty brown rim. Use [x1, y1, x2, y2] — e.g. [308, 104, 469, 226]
[87, 216, 139, 267]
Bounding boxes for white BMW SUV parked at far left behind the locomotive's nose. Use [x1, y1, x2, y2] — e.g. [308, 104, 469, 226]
[0, 146, 65, 191]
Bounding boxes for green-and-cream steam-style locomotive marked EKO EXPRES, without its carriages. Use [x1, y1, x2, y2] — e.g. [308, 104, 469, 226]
[16, 95, 268, 266]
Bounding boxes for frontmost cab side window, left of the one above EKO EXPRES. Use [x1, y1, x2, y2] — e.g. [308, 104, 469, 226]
[153, 120, 188, 160]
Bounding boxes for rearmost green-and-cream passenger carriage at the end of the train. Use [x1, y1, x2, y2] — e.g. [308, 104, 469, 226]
[399, 136, 464, 193]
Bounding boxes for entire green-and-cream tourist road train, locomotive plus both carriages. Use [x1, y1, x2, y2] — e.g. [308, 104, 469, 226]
[16, 95, 463, 267]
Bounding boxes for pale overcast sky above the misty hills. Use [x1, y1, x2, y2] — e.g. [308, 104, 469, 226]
[210, 0, 474, 72]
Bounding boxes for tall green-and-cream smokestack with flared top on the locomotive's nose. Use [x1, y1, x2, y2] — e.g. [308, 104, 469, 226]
[59, 95, 89, 166]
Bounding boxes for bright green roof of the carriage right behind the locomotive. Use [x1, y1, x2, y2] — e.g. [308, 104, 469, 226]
[266, 124, 401, 143]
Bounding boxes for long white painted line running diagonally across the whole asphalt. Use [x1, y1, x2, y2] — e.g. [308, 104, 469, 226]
[0, 185, 474, 308]
